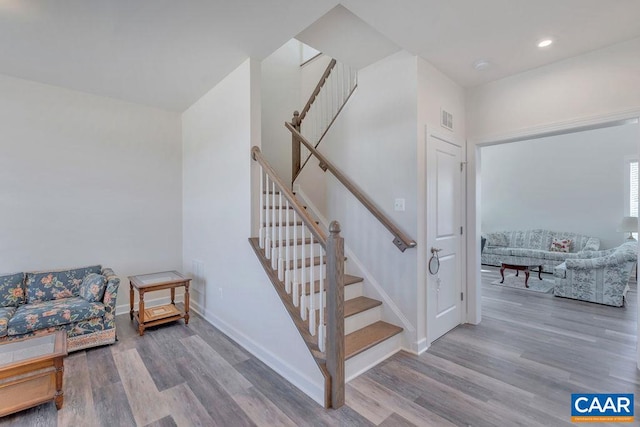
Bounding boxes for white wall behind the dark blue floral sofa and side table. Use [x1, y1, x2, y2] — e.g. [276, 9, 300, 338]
[0, 76, 182, 311]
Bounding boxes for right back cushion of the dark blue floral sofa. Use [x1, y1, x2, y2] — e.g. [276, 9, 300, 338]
[26, 265, 101, 304]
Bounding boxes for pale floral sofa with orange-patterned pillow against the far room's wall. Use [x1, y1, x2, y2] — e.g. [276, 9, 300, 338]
[481, 229, 600, 273]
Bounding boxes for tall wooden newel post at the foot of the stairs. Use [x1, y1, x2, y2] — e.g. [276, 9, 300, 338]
[326, 221, 345, 408]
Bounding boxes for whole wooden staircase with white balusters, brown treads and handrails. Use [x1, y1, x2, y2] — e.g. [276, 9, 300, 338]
[249, 55, 416, 408]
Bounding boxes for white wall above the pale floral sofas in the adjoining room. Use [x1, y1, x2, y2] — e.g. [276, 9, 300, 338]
[481, 124, 639, 248]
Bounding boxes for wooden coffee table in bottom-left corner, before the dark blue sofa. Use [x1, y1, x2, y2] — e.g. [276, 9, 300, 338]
[0, 331, 67, 417]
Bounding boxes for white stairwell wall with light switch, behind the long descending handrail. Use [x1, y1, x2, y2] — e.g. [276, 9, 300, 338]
[316, 53, 417, 344]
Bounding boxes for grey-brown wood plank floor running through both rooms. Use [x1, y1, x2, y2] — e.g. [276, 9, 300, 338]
[0, 267, 640, 427]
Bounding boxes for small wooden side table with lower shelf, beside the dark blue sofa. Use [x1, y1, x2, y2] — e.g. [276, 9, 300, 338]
[129, 271, 191, 335]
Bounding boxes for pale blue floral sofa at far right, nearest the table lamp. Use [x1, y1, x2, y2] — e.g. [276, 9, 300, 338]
[553, 241, 638, 307]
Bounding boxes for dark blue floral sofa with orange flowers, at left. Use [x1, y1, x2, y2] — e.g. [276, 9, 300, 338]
[0, 265, 120, 351]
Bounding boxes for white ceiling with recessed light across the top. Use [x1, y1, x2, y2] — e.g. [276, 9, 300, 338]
[0, 0, 640, 111]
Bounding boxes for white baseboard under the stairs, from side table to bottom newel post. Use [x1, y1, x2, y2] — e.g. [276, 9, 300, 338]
[186, 304, 324, 407]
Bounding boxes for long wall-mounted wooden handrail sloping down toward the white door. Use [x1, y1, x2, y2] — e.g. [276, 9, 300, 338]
[284, 122, 416, 252]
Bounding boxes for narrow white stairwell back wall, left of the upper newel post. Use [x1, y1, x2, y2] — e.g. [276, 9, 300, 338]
[260, 39, 304, 186]
